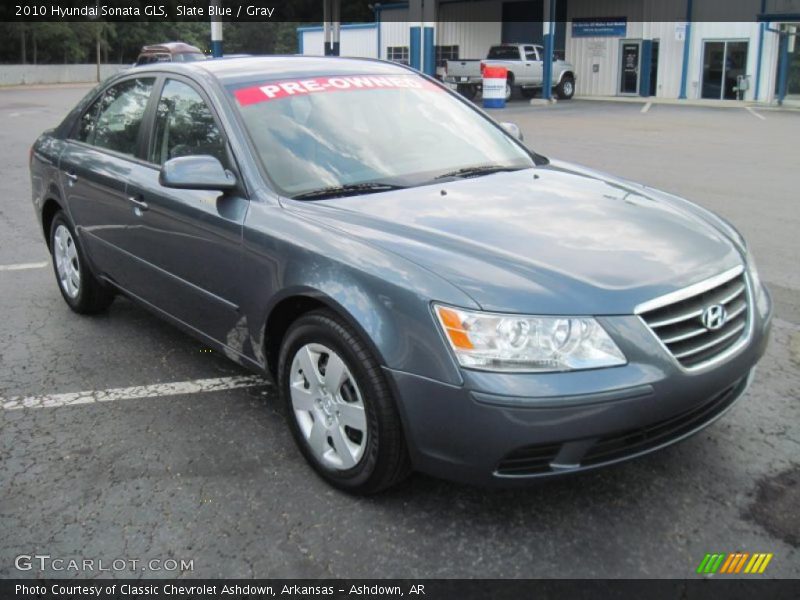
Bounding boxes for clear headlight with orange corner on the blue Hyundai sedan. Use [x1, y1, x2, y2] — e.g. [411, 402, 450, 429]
[434, 305, 626, 372]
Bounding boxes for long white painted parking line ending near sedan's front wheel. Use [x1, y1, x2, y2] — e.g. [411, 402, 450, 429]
[0, 375, 271, 410]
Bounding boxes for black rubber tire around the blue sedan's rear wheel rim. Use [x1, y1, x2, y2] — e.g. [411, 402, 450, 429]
[50, 211, 114, 315]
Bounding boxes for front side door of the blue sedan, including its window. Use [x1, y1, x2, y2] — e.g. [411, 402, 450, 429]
[122, 75, 249, 352]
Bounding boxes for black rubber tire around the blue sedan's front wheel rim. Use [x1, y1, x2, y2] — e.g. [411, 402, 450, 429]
[278, 310, 411, 495]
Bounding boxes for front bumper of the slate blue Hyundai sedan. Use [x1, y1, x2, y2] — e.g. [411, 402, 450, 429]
[386, 292, 771, 485]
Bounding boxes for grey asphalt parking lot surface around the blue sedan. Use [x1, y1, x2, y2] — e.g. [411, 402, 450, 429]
[0, 86, 800, 578]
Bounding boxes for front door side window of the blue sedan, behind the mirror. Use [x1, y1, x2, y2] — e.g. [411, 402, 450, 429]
[149, 79, 227, 165]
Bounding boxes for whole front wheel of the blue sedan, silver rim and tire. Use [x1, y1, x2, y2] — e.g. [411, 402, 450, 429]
[278, 311, 410, 494]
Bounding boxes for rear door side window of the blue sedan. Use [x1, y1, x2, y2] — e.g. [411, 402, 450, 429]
[91, 78, 155, 156]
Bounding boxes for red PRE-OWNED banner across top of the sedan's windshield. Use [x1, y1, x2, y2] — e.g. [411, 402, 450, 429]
[234, 75, 440, 106]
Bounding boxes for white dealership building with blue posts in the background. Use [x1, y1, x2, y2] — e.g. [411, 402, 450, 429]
[297, 0, 800, 104]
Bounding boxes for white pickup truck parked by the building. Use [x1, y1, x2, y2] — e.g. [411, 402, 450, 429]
[444, 44, 575, 100]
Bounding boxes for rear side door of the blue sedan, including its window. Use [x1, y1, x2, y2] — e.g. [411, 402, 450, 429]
[59, 76, 156, 286]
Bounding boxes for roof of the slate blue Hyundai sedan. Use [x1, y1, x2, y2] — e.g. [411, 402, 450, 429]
[132, 55, 416, 86]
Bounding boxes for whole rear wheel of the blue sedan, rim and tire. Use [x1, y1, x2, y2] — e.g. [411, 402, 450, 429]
[50, 211, 114, 314]
